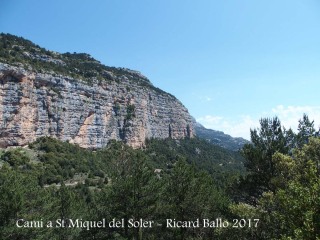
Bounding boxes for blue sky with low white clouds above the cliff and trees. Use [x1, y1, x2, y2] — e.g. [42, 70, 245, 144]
[0, 0, 320, 139]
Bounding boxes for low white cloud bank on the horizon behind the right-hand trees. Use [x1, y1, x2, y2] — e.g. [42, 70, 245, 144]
[197, 105, 320, 140]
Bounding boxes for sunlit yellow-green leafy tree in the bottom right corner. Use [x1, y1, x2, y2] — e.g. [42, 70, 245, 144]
[259, 138, 320, 239]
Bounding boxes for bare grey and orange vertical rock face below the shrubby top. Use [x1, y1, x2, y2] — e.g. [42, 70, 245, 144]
[0, 63, 194, 148]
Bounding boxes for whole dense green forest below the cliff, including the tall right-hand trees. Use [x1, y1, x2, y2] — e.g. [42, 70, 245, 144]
[0, 115, 320, 240]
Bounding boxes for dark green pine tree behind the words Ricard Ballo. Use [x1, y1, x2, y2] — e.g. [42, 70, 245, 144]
[161, 159, 229, 239]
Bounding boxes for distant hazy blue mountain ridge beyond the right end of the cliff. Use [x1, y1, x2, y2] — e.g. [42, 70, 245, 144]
[194, 122, 250, 151]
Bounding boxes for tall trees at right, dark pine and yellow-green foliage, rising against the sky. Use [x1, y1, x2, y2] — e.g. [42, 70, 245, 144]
[232, 115, 320, 239]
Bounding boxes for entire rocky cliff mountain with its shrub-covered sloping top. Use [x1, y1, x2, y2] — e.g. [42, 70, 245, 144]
[0, 34, 194, 148]
